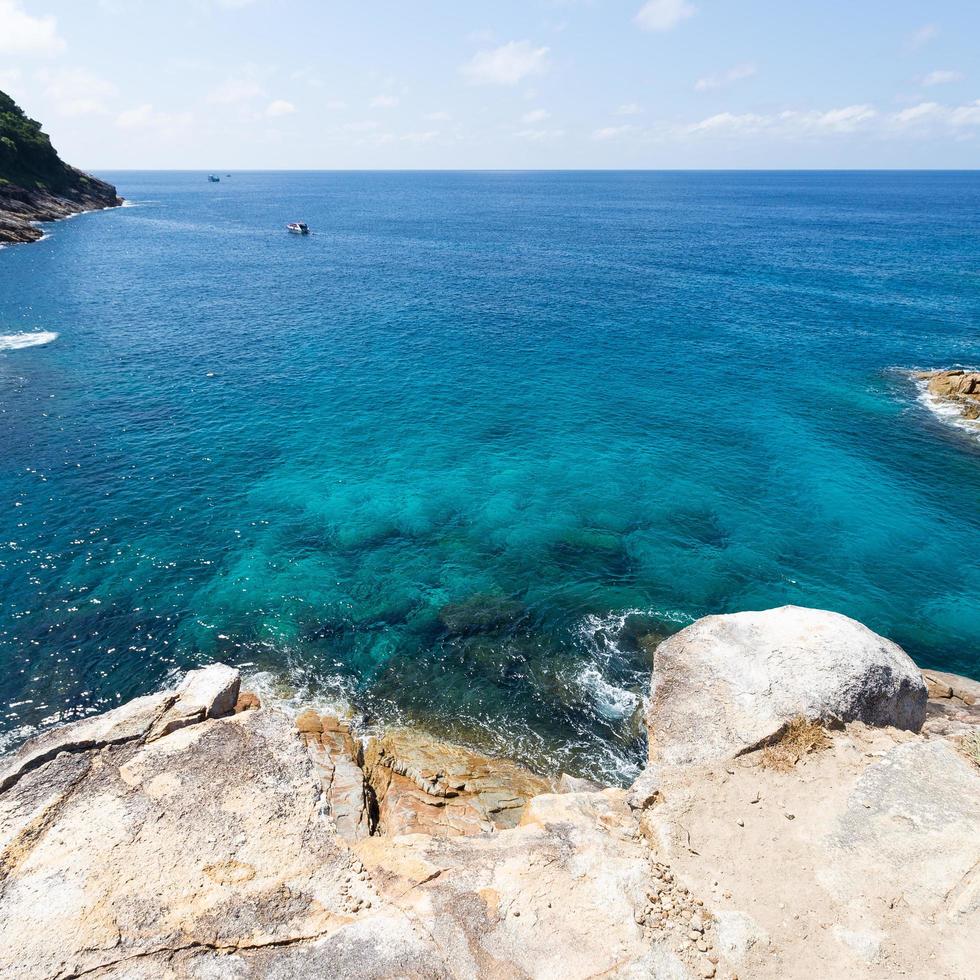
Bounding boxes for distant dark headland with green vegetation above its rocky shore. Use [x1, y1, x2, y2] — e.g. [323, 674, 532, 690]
[0, 92, 122, 244]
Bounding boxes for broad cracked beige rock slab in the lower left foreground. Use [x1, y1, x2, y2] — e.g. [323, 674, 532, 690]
[0, 711, 349, 977]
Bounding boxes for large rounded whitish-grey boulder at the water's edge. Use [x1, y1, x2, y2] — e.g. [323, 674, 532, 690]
[648, 606, 927, 764]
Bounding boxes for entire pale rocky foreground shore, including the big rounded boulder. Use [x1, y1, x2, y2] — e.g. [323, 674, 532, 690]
[0, 607, 980, 980]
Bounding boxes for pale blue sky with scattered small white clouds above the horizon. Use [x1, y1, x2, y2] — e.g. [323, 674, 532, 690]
[0, 0, 980, 170]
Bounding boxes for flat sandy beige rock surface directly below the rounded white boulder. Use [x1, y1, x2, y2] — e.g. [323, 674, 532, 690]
[641, 723, 980, 980]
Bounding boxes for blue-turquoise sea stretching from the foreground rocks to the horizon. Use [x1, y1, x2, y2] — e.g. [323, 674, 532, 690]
[0, 173, 980, 778]
